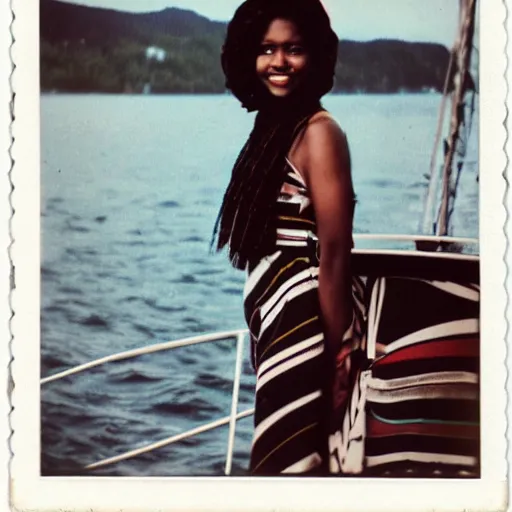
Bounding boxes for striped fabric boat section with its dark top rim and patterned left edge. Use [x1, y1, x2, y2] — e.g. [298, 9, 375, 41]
[329, 260, 480, 478]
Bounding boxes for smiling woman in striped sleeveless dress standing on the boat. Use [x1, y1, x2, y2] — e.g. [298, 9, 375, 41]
[212, 0, 362, 475]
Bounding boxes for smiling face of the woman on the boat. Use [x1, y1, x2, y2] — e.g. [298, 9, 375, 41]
[256, 18, 309, 97]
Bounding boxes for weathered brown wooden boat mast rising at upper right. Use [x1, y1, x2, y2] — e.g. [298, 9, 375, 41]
[435, 0, 476, 236]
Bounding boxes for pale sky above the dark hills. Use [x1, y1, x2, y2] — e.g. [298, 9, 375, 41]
[60, 0, 459, 47]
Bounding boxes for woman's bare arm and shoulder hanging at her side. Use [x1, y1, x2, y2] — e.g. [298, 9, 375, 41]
[290, 112, 354, 354]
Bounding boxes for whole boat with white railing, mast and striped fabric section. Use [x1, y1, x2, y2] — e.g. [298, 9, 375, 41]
[41, 0, 480, 477]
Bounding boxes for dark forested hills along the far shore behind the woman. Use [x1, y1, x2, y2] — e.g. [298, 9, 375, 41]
[40, 0, 449, 94]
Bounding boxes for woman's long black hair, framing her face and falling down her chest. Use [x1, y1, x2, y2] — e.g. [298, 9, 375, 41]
[212, 0, 338, 269]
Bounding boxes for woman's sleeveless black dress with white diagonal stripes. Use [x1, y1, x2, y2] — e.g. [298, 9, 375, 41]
[244, 161, 365, 476]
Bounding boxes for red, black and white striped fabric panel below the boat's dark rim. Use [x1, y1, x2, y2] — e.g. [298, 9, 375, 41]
[365, 276, 480, 477]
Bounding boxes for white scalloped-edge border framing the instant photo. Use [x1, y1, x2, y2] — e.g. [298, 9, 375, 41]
[11, 0, 507, 512]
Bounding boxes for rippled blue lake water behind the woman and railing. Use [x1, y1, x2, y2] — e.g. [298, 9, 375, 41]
[41, 94, 478, 476]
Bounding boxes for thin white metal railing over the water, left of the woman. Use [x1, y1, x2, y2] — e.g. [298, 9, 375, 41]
[40, 329, 254, 475]
